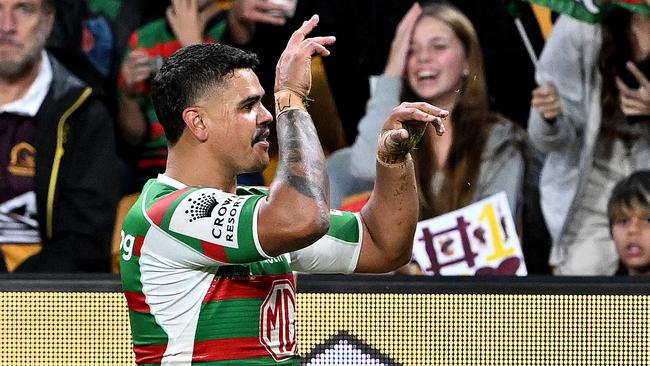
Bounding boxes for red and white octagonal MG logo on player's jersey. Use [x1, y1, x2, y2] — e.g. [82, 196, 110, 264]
[260, 279, 297, 361]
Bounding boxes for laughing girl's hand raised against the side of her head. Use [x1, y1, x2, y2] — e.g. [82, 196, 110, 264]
[384, 2, 422, 77]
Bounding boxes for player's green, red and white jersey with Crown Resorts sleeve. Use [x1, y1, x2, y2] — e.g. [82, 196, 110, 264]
[120, 175, 362, 365]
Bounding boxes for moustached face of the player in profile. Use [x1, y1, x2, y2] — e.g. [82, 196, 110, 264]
[198, 69, 273, 174]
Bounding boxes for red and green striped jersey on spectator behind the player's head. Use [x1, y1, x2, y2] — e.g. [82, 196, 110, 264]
[118, 17, 227, 177]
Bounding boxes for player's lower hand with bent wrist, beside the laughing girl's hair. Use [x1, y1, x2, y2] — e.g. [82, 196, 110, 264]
[377, 102, 449, 164]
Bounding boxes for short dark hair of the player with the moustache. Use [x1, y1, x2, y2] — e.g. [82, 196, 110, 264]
[151, 44, 259, 145]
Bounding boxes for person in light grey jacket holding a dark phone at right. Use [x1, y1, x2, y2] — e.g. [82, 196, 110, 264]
[528, 0, 650, 275]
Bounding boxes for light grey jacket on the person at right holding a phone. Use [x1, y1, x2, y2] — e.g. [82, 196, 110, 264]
[528, 16, 650, 267]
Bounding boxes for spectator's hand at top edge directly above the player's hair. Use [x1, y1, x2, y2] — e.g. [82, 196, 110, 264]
[167, 0, 221, 47]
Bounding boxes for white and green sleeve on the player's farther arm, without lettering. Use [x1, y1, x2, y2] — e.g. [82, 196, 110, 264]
[290, 210, 363, 273]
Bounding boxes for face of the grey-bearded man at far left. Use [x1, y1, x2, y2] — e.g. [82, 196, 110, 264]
[0, 0, 54, 78]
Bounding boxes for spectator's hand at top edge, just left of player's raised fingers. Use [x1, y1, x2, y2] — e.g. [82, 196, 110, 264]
[228, 0, 289, 44]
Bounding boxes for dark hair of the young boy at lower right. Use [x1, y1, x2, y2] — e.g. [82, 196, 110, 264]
[607, 170, 650, 228]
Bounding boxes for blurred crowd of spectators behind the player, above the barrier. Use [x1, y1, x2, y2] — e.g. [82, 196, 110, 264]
[0, 0, 650, 276]
